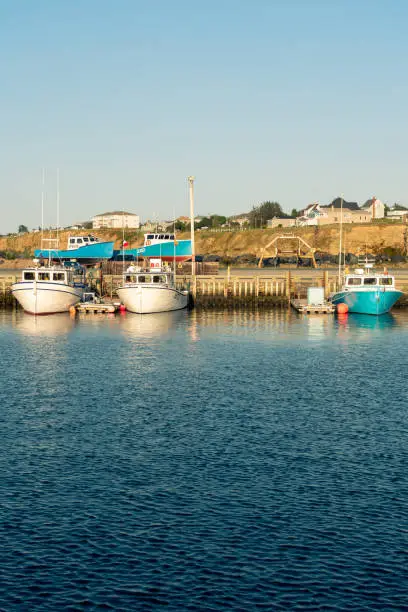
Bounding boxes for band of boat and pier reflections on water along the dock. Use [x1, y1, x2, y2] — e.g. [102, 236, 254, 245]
[0, 308, 408, 343]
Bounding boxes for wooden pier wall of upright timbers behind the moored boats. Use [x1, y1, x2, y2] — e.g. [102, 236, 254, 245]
[0, 270, 408, 308]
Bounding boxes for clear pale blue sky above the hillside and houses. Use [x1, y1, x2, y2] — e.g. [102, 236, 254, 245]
[0, 0, 408, 233]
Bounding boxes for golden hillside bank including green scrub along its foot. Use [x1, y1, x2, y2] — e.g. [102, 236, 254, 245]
[0, 222, 408, 269]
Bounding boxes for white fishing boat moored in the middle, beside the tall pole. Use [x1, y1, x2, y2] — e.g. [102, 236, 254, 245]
[117, 266, 188, 314]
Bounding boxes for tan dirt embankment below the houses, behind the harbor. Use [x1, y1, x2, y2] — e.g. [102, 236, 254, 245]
[0, 223, 408, 268]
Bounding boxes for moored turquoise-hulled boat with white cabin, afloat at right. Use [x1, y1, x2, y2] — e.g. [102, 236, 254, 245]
[330, 264, 403, 315]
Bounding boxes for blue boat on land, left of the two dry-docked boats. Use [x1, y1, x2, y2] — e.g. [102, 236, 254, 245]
[34, 235, 114, 265]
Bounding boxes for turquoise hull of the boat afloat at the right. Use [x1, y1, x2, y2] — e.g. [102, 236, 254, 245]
[331, 288, 403, 315]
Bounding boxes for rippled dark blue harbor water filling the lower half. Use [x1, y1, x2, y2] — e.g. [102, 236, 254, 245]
[0, 310, 408, 611]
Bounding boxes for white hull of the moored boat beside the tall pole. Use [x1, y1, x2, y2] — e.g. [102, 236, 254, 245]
[118, 285, 188, 314]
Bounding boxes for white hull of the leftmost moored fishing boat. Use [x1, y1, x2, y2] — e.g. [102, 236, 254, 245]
[11, 281, 84, 315]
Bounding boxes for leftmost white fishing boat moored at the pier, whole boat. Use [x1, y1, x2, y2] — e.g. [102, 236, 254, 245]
[11, 265, 86, 315]
